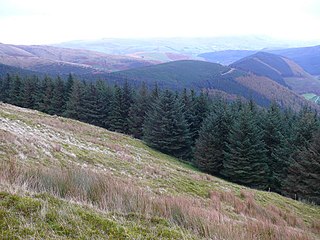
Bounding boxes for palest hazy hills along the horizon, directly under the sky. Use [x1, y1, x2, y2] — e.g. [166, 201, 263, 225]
[54, 36, 314, 64]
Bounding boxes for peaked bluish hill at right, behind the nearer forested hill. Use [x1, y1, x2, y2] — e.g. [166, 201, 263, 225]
[230, 52, 320, 94]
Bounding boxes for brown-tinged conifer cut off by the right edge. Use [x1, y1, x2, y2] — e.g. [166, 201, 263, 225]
[284, 130, 320, 204]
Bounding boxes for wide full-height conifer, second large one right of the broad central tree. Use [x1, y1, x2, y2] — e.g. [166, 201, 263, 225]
[222, 106, 269, 189]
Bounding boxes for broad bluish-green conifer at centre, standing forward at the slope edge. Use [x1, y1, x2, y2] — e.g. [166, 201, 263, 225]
[143, 90, 191, 159]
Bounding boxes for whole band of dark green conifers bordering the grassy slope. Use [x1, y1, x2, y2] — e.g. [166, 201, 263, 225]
[0, 74, 320, 204]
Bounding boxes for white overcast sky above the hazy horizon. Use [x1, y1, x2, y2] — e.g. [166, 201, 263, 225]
[0, 0, 320, 44]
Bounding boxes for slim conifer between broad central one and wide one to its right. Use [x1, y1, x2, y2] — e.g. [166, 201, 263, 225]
[195, 101, 232, 175]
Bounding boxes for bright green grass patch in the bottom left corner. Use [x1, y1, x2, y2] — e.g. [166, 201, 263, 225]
[0, 192, 191, 239]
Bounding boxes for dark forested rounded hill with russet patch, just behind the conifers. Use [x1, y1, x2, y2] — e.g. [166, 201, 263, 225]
[94, 60, 314, 109]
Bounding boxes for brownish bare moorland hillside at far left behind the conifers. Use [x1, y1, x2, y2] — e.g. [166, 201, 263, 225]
[0, 44, 152, 75]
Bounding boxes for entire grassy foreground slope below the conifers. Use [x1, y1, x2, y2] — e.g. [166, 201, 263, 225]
[0, 104, 320, 239]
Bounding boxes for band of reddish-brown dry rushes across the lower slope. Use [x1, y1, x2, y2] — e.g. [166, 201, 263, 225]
[0, 159, 319, 240]
